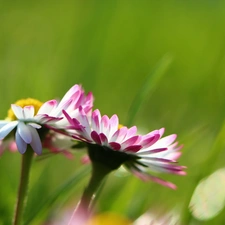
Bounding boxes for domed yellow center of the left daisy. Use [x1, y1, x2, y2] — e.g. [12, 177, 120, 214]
[6, 98, 43, 121]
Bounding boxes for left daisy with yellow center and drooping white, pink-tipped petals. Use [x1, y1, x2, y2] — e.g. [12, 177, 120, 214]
[0, 85, 93, 155]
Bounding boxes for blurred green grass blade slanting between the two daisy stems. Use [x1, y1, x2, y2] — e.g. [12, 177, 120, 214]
[24, 167, 90, 225]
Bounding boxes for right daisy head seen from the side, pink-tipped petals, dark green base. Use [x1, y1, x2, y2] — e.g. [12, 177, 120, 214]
[63, 107, 186, 189]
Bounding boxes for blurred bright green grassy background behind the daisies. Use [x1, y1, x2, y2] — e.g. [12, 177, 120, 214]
[0, 0, 225, 225]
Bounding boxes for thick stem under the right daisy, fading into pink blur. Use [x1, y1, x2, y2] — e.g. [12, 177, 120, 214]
[69, 162, 112, 225]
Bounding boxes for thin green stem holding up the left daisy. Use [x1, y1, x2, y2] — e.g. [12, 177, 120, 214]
[13, 146, 33, 225]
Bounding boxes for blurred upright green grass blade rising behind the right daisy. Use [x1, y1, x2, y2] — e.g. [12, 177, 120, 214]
[126, 54, 172, 126]
